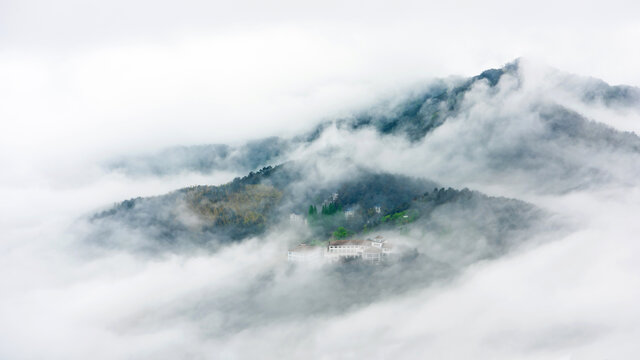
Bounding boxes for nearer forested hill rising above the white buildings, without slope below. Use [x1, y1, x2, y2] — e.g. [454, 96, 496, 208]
[92, 163, 542, 252]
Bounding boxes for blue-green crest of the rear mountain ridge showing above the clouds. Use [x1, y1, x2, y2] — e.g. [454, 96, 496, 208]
[106, 59, 640, 186]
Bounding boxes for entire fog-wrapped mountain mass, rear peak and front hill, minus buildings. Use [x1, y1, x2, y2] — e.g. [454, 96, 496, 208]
[87, 61, 624, 330]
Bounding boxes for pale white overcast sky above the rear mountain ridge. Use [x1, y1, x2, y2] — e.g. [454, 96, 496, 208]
[0, 0, 640, 166]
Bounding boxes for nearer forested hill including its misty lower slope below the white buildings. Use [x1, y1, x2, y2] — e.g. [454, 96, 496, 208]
[89, 162, 553, 335]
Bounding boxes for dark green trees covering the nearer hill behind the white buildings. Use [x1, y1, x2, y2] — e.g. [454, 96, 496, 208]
[93, 160, 540, 253]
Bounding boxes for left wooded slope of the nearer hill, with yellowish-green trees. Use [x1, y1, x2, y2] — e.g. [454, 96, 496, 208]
[91, 167, 284, 243]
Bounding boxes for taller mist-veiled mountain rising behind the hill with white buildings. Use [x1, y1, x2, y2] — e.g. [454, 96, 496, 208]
[107, 60, 640, 197]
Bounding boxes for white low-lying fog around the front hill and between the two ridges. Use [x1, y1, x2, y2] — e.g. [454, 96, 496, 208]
[0, 43, 640, 359]
